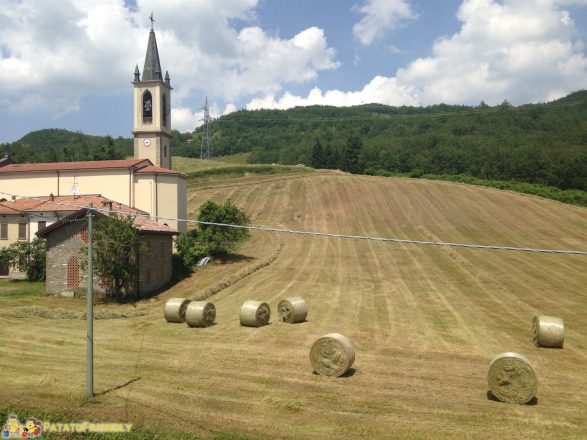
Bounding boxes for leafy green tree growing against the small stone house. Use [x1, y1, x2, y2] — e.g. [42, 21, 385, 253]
[93, 216, 146, 300]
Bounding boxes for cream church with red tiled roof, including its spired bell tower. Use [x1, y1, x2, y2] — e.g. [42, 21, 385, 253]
[0, 26, 187, 235]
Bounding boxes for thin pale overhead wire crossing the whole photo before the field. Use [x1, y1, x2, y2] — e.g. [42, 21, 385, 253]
[0, 191, 587, 255]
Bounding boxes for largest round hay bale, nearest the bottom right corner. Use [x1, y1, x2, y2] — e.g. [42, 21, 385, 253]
[487, 352, 538, 404]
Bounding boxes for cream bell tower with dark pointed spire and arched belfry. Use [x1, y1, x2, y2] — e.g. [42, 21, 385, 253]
[132, 15, 172, 168]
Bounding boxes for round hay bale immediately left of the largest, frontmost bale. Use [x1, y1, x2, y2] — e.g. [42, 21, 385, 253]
[310, 333, 355, 377]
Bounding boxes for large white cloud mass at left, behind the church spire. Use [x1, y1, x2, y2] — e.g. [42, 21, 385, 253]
[0, 0, 338, 115]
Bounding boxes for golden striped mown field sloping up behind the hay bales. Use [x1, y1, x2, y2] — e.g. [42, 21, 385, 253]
[0, 165, 587, 439]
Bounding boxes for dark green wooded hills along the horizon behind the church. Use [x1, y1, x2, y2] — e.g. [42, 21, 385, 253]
[0, 91, 587, 190]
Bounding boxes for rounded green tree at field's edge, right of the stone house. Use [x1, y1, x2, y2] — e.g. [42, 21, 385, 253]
[198, 200, 250, 257]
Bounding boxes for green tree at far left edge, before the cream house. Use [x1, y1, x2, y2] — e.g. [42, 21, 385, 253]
[0, 237, 47, 281]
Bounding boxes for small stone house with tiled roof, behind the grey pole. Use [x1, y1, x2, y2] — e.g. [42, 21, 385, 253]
[37, 203, 178, 296]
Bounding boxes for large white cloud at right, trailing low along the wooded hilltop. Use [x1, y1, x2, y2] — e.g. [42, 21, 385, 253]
[255, 0, 587, 109]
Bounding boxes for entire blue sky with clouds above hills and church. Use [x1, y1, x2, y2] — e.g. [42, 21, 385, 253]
[0, 0, 587, 142]
